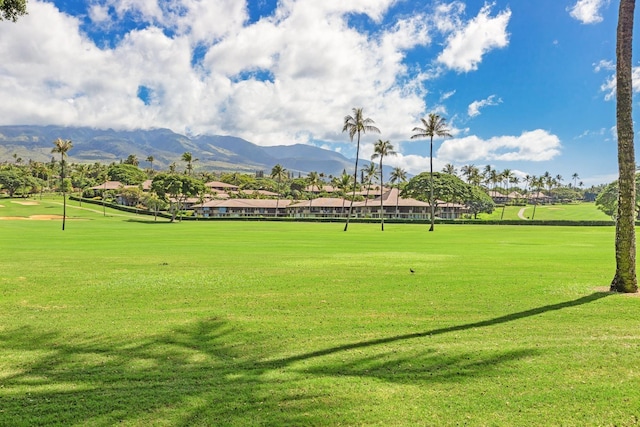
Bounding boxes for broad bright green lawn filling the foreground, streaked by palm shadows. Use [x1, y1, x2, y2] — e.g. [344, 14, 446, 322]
[0, 199, 640, 426]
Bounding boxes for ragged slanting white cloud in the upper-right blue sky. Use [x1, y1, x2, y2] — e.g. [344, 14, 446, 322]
[437, 4, 511, 72]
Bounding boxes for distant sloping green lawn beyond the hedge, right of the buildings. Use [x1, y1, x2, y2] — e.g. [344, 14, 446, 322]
[478, 202, 611, 221]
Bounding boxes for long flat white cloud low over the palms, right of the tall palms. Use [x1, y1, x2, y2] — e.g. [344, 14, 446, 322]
[437, 129, 561, 163]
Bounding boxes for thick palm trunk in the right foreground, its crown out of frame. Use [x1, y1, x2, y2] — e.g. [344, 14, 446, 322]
[610, 0, 638, 293]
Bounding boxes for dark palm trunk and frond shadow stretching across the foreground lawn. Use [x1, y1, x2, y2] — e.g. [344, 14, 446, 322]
[0, 293, 609, 426]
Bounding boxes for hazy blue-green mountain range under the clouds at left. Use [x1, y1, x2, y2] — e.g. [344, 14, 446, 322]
[0, 126, 362, 176]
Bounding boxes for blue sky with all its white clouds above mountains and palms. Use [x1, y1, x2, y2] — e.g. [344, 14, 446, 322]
[0, 0, 637, 186]
